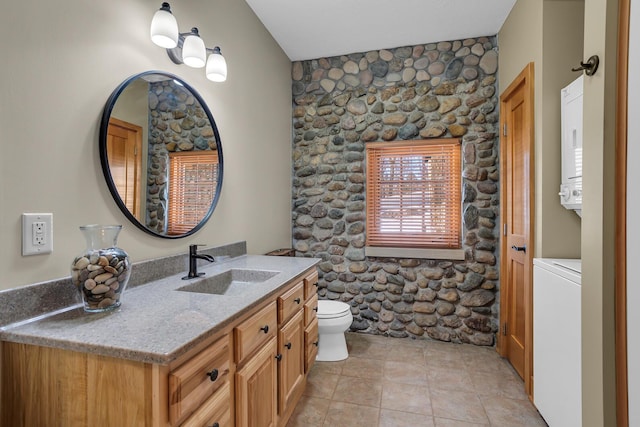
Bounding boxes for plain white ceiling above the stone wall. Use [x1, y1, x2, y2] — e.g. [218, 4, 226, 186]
[246, 0, 516, 61]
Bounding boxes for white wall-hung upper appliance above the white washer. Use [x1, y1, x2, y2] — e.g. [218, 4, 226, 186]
[559, 75, 584, 215]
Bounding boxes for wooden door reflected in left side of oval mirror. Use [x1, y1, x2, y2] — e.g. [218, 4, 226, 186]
[107, 118, 142, 220]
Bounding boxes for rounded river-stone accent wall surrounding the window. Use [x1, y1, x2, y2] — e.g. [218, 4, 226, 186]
[292, 37, 500, 345]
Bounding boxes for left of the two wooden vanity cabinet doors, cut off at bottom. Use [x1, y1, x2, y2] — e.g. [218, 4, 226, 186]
[236, 337, 278, 427]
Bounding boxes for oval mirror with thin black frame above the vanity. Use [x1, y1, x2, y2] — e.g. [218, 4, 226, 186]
[100, 71, 223, 239]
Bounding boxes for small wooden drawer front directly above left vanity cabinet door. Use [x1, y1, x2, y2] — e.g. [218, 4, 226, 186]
[235, 301, 278, 363]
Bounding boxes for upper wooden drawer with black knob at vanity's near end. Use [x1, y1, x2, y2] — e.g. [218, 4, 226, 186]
[169, 335, 231, 425]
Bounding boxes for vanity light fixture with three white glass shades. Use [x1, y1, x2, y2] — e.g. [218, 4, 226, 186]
[151, 2, 227, 82]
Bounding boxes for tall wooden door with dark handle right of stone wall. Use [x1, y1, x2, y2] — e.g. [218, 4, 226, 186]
[498, 63, 534, 396]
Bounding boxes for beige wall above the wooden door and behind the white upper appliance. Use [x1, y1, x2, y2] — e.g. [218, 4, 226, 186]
[498, 0, 584, 258]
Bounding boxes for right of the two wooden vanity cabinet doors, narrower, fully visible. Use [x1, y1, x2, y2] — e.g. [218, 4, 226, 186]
[278, 310, 305, 415]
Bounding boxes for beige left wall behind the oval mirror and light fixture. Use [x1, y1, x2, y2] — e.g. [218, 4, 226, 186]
[0, 0, 291, 289]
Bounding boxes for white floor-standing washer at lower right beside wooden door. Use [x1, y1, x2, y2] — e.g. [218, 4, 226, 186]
[533, 258, 582, 427]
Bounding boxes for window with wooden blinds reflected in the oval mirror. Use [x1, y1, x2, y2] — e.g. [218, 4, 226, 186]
[167, 150, 218, 235]
